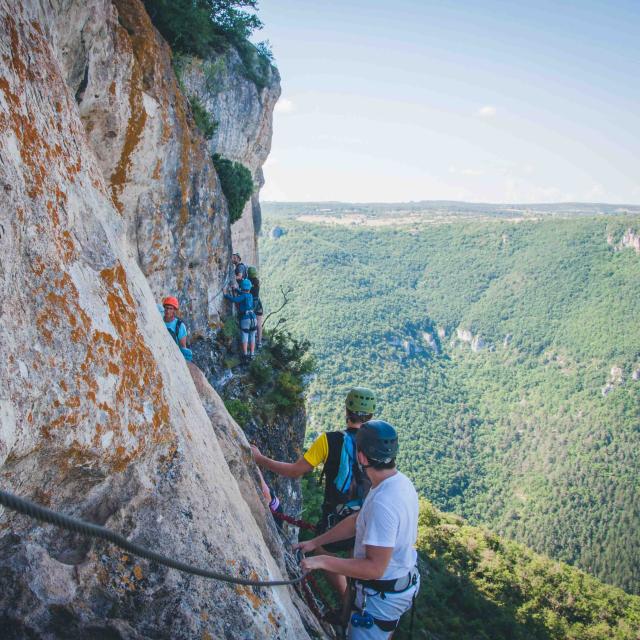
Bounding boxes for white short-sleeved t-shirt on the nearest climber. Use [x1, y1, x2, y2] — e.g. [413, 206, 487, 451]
[353, 471, 418, 580]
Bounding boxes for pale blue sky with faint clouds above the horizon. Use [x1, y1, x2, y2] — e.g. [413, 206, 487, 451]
[254, 0, 640, 204]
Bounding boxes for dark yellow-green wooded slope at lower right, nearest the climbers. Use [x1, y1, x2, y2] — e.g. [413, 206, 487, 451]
[394, 502, 640, 640]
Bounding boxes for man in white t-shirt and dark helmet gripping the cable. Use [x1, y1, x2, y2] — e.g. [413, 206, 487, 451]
[297, 420, 420, 640]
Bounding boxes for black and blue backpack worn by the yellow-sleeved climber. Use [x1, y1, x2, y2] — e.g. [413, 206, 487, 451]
[322, 429, 371, 529]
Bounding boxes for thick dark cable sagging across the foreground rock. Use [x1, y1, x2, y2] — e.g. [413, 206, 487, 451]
[0, 490, 304, 587]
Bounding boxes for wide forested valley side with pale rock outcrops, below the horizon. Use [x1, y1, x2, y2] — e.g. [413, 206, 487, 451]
[261, 215, 640, 593]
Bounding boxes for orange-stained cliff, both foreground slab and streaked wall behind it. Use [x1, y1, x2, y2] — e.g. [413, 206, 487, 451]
[0, 0, 318, 638]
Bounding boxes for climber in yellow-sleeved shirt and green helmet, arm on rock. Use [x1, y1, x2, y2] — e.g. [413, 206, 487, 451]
[251, 387, 376, 595]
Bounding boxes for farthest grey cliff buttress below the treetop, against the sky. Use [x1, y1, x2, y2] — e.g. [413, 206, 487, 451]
[182, 48, 280, 265]
